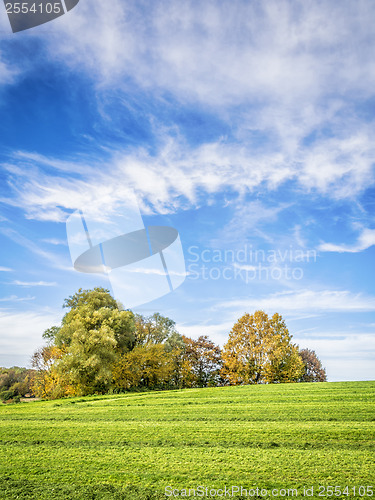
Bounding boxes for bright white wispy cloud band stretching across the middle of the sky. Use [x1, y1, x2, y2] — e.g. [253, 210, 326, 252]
[1, 128, 375, 224]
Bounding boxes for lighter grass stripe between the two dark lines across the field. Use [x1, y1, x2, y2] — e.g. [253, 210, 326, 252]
[0, 420, 375, 450]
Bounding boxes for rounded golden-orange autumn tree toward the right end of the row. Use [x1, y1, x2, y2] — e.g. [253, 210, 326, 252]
[222, 311, 303, 385]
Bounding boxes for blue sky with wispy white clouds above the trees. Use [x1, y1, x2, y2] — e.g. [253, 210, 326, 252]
[0, 0, 375, 381]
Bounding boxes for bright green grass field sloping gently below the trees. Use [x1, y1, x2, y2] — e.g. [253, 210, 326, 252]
[0, 382, 375, 500]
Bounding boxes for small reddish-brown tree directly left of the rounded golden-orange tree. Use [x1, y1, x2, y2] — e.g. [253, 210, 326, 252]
[182, 335, 222, 387]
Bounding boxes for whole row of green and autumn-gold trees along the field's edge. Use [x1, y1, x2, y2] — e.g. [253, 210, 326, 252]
[0, 288, 326, 399]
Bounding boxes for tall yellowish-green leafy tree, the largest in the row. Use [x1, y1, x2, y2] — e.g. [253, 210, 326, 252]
[56, 288, 135, 394]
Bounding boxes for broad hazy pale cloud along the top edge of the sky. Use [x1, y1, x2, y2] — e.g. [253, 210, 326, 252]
[44, 0, 375, 107]
